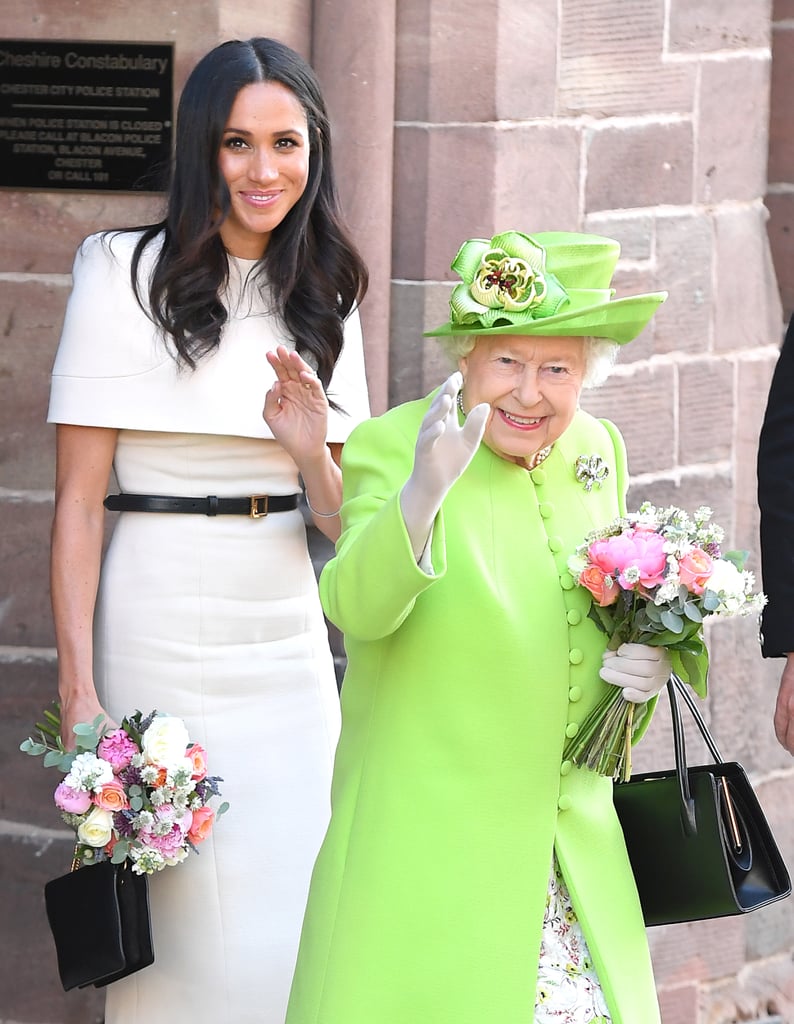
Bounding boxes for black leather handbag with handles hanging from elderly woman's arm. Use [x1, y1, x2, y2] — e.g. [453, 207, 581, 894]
[614, 676, 791, 925]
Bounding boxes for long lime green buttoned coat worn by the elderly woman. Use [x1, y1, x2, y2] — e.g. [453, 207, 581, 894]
[287, 398, 659, 1024]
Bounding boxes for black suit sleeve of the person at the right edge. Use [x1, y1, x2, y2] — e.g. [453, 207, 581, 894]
[758, 316, 794, 657]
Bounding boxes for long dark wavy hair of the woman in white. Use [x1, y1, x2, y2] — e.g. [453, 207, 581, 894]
[126, 38, 368, 388]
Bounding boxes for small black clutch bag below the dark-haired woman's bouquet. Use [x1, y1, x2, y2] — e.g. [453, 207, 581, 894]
[44, 860, 155, 991]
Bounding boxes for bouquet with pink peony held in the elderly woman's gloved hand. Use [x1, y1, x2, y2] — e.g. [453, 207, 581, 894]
[563, 502, 766, 781]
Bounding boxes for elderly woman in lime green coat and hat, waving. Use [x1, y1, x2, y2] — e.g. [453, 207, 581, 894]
[287, 231, 669, 1024]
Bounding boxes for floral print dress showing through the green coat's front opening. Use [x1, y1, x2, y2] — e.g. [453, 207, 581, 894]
[535, 857, 612, 1024]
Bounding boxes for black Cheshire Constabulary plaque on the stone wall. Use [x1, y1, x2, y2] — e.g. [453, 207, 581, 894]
[0, 39, 173, 193]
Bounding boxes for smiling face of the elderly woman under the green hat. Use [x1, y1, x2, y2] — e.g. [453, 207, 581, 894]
[458, 335, 586, 463]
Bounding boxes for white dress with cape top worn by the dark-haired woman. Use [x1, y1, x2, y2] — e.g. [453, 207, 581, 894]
[48, 236, 368, 1024]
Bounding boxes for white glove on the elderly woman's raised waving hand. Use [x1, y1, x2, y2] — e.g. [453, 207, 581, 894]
[400, 371, 491, 561]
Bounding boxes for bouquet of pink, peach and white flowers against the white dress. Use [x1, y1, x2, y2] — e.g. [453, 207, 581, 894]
[19, 705, 228, 874]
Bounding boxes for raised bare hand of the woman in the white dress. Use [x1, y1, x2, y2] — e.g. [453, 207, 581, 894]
[262, 345, 328, 467]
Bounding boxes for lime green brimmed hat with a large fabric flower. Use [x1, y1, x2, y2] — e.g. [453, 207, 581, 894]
[424, 231, 667, 345]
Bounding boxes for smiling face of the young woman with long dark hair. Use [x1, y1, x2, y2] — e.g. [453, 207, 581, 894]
[218, 82, 309, 259]
